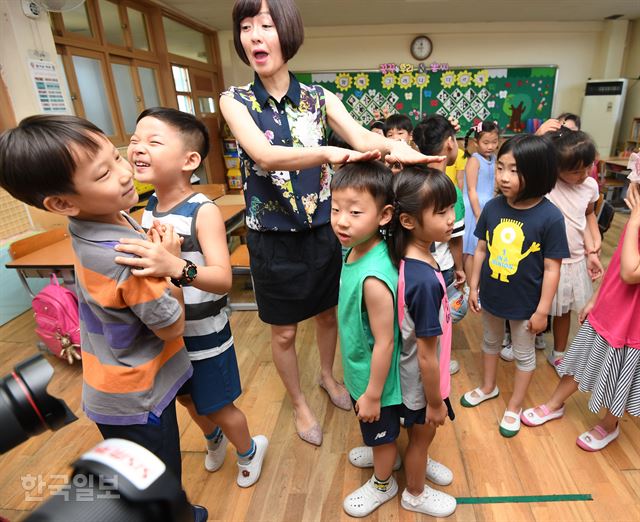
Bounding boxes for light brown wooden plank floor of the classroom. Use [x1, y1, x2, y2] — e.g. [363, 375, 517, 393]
[0, 209, 640, 522]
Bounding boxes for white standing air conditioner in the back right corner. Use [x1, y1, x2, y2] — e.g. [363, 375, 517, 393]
[581, 78, 627, 159]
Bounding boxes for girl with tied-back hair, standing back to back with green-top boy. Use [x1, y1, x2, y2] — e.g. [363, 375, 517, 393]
[389, 167, 456, 517]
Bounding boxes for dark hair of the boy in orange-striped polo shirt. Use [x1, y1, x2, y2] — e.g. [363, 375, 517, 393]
[0, 115, 107, 210]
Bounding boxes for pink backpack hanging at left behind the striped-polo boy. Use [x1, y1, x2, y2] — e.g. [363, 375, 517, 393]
[31, 274, 81, 364]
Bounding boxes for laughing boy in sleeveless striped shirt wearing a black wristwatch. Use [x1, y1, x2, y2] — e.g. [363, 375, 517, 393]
[116, 107, 269, 487]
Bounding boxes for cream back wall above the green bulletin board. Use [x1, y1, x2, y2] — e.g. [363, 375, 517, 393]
[218, 20, 640, 144]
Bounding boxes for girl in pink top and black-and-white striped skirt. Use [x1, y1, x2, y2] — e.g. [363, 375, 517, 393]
[521, 179, 640, 451]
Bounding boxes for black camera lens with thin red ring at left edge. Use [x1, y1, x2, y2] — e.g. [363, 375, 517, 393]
[0, 355, 77, 453]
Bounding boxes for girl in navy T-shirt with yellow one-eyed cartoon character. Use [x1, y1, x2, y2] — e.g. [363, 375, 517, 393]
[460, 135, 569, 437]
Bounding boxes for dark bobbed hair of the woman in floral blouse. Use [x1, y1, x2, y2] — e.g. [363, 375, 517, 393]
[232, 0, 304, 65]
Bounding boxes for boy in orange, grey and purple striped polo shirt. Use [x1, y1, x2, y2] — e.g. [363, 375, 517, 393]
[0, 115, 207, 521]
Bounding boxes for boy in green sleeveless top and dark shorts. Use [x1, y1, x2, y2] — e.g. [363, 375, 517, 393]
[331, 162, 402, 517]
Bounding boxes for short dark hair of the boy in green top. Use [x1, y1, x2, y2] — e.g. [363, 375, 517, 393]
[331, 161, 393, 209]
